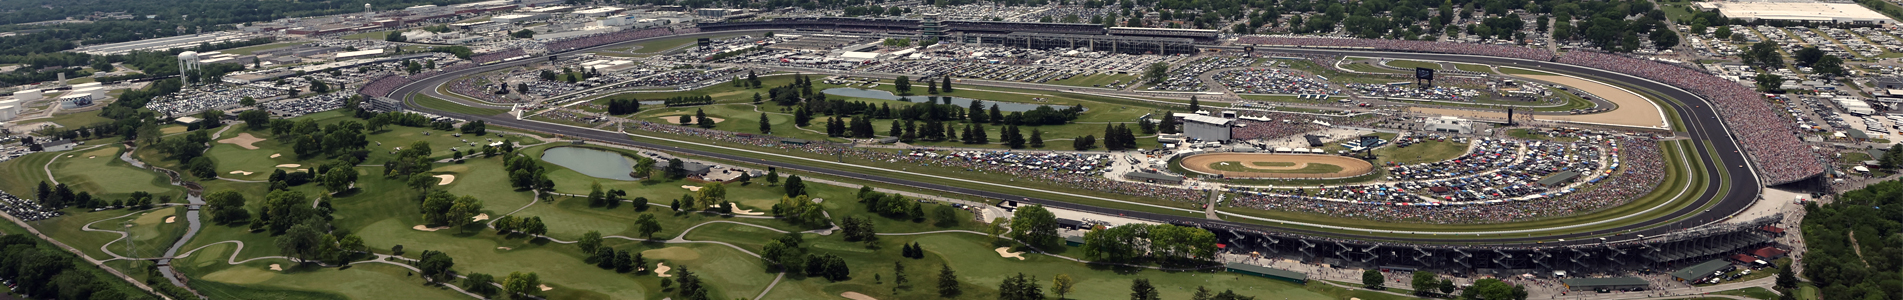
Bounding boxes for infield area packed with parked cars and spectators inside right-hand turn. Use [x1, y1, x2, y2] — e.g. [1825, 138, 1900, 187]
[1231, 137, 1665, 224]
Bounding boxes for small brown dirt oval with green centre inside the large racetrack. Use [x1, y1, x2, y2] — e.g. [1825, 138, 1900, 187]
[1182, 154, 1374, 178]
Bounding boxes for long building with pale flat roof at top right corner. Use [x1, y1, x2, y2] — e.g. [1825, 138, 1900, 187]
[1692, 0, 1897, 25]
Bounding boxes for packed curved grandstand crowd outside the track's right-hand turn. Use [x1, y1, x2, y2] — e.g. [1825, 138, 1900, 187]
[1559, 51, 1827, 184]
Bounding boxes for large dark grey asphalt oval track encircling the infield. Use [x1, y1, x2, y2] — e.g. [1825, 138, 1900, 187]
[392, 32, 1762, 245]
